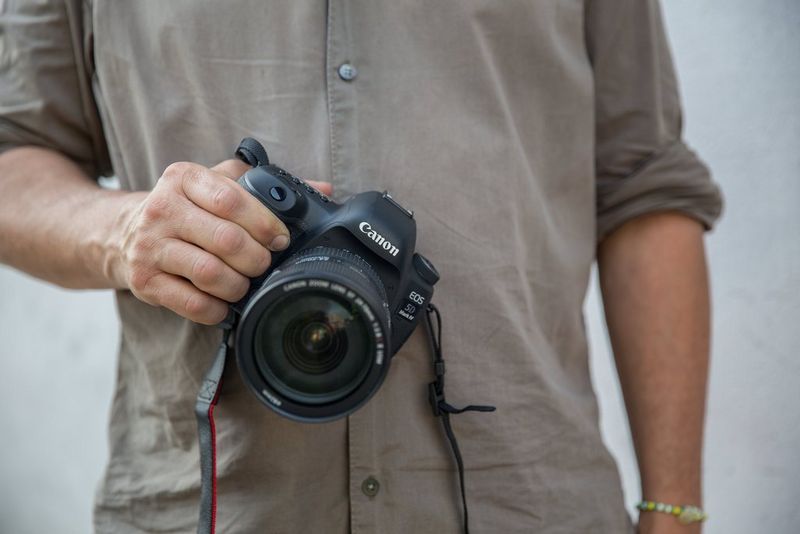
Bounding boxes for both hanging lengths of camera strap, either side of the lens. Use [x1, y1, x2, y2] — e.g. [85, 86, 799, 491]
[194, 304, 495, 534]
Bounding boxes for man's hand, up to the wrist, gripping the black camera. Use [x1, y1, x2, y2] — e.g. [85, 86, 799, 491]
[106, 160, 331, 324]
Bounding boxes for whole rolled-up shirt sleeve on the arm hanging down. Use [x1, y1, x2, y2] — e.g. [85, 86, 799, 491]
[586, 0, 722, 241]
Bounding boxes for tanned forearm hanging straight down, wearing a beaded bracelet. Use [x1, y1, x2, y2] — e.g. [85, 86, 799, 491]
[598, 213, 709, 533]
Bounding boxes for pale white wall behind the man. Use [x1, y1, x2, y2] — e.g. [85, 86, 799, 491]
[0, 0, 800, 534]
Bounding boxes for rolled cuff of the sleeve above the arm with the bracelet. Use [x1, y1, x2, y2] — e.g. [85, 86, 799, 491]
[597, 141, 722, 242]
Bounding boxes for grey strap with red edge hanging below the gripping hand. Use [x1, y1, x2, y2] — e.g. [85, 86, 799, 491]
[194, 327, 230, 534]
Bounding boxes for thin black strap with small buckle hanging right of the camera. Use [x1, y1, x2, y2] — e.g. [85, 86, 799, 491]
[425, 304, 496, 534]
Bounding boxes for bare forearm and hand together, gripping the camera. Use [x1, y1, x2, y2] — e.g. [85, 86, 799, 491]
[0, 147, 331, 318]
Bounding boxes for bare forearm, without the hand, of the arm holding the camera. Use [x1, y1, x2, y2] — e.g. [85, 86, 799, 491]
[0, 147, 143, 288]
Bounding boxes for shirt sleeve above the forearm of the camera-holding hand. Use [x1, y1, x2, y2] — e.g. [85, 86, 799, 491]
[0, 0, 111, 178]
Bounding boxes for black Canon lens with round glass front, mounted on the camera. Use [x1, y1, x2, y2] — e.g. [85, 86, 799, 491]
[235, 247, 390, 422]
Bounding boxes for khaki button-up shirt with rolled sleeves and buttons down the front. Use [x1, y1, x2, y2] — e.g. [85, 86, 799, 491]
[0, 0, 720, 534]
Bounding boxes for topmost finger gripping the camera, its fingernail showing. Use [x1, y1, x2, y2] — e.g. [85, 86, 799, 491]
[181, 166, 289, 251]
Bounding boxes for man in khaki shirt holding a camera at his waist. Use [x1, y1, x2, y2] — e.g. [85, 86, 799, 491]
[0, 0, 721, 534]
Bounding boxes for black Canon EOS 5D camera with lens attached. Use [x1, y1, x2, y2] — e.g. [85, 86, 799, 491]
[232, 138, 439, 422]
